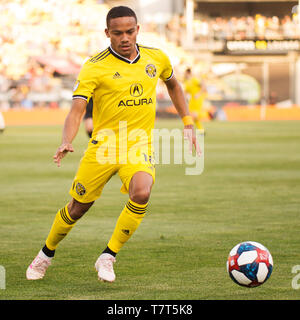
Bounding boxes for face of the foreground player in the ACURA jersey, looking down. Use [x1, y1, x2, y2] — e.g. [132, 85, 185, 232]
[105, 17, 139, 60]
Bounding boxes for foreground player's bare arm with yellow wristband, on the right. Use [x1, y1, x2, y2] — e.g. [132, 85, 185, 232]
[165, 75, 201, 156]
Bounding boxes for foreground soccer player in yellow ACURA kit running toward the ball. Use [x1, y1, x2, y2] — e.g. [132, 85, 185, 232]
[26, 6, 201, 282]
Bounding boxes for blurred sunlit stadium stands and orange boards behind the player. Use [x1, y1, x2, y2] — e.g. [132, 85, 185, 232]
[0, 0, 300, 126]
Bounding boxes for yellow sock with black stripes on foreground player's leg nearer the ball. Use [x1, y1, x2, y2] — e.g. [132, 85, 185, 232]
[107, 199, 148, 253]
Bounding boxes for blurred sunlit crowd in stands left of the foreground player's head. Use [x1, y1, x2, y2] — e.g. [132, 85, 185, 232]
[0, 0, 108, 108]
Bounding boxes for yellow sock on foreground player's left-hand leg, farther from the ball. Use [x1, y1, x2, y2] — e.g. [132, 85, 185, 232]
[46, 205, 76, 250]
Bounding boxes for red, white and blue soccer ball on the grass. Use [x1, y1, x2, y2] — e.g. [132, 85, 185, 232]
[226, 241, 273, 287]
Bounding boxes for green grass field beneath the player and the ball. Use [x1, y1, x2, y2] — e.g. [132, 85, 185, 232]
[0, 120, 300, 300]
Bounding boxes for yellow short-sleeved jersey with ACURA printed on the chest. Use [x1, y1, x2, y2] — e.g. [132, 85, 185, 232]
[73, 44, 173, 151]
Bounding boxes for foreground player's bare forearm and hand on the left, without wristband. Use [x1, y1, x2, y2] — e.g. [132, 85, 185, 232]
[53, 99, 87, 167]
